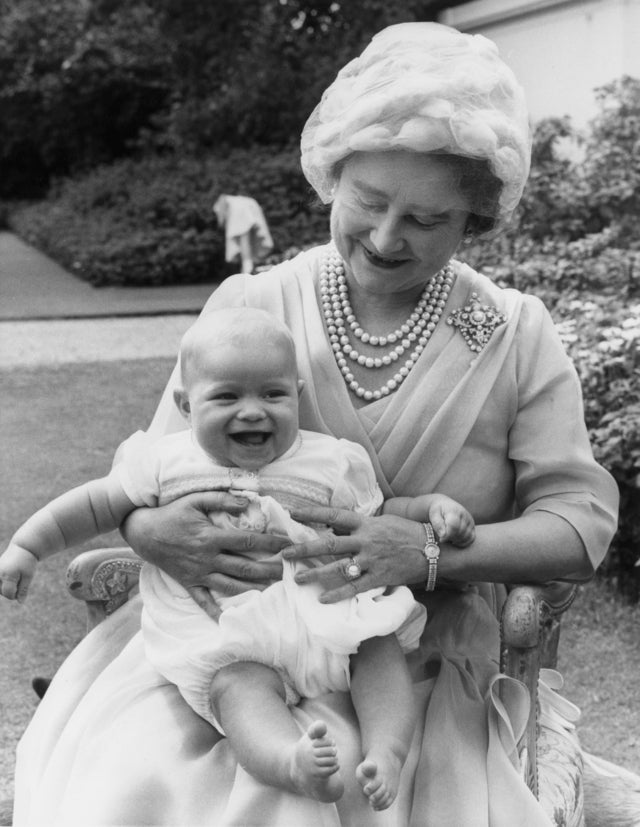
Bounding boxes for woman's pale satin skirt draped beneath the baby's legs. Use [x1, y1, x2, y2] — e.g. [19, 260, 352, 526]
[14, 592, 552, 827]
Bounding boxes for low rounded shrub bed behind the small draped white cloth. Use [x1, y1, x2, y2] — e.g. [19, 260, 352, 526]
[11, 148, 328, 286]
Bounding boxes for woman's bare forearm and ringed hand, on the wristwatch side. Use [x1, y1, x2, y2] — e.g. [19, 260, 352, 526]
[283, 508, 593, 603]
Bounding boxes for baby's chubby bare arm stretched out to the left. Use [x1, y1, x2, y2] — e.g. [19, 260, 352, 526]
[0, 476, 135, 602]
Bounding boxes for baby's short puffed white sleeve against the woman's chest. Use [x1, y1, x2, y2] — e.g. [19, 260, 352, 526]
[331, 439, 383, 516]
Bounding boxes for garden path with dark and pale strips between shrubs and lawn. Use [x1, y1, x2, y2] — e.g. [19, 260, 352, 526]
[0, 232, 221, 369]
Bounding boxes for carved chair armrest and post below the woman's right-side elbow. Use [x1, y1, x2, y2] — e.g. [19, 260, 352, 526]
[500, 582, 577, 796]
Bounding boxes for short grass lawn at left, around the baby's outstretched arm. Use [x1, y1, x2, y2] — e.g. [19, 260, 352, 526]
[0, 359, 174, 800]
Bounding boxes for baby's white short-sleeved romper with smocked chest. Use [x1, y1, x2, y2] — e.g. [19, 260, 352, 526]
[111, 430, 426, 732]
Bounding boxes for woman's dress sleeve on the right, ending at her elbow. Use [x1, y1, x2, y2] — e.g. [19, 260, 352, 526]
[509, 296, 618, 569]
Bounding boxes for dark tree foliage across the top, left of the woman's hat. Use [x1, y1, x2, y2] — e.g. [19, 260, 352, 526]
[0, 0, 435, 196]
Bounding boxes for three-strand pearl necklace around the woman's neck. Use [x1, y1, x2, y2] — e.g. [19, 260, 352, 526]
[320, 249, 453, 402]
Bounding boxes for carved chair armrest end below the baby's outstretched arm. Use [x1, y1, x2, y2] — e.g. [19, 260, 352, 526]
[67, 548, 142, 630]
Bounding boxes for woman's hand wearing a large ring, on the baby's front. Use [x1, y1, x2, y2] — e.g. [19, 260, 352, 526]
[283, 506, 427, 603]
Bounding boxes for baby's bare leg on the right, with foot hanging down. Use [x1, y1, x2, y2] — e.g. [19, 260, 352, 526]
[351, 635, 416, 810]
